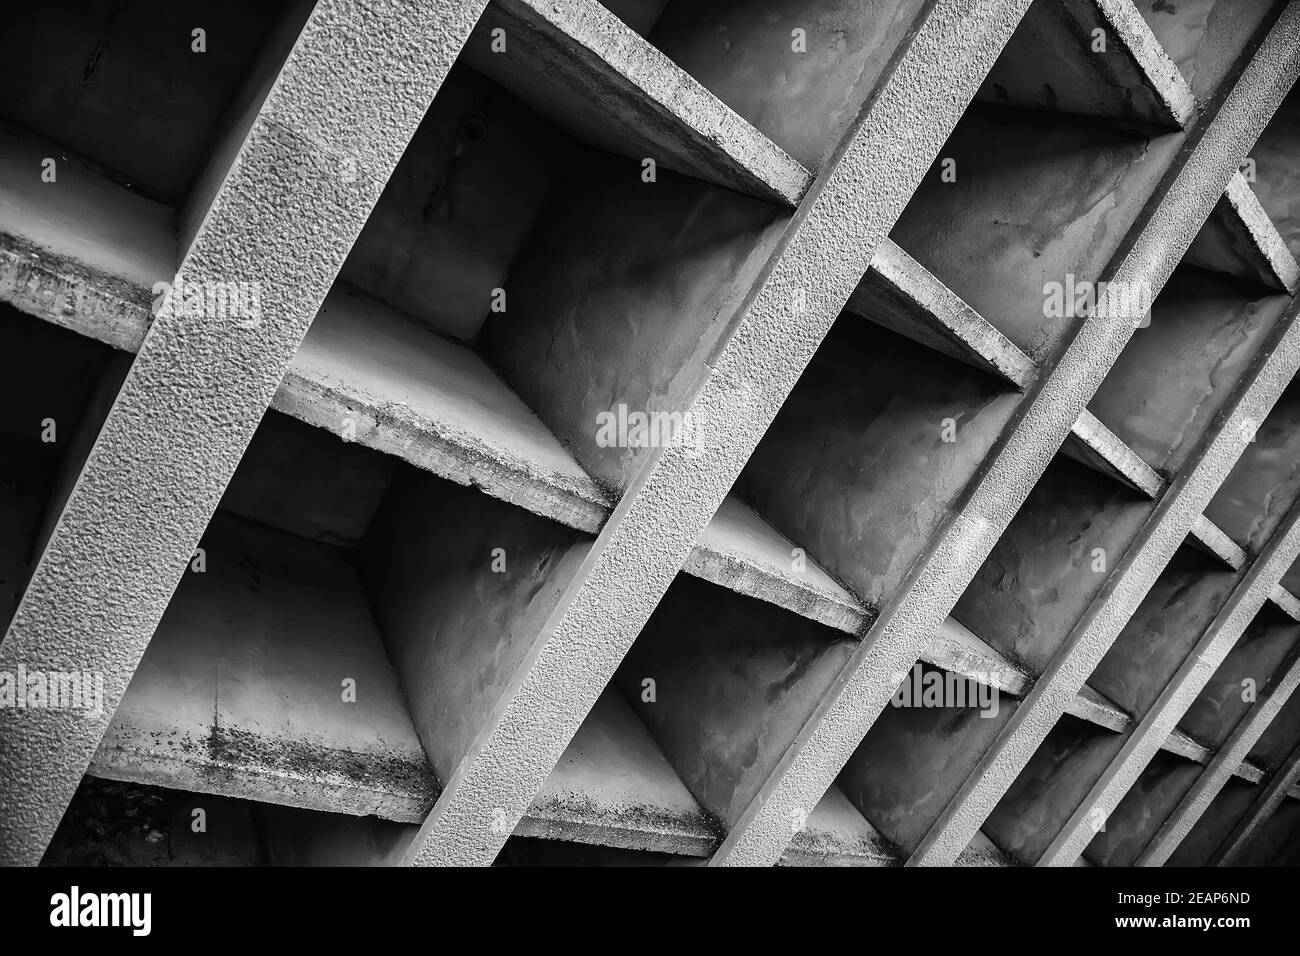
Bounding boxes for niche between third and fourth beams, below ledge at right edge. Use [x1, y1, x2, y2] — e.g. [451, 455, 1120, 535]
[1088, 265, 1288, 475]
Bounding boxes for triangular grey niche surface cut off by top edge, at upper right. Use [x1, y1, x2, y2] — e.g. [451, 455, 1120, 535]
[1134, 0, 1283, 103]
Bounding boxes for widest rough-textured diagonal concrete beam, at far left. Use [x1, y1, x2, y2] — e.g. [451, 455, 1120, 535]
[0, 0, 486, 864]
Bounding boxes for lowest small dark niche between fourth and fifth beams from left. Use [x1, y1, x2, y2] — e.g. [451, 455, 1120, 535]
[984, 714, 1125, 865]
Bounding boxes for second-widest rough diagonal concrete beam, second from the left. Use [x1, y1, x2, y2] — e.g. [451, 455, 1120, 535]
[395, 0, 1028, 864]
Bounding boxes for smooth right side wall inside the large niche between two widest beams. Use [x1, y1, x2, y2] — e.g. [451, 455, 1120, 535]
[482, 151, 789, 492]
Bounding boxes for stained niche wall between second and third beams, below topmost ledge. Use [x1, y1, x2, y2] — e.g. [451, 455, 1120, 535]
[892, 104, 1182, 363]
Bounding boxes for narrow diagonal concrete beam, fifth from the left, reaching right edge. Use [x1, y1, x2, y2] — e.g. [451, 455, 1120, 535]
[1039, 496, 1300, 866]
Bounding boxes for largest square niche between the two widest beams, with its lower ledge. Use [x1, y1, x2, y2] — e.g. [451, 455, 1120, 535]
[327, 41, 789, 509]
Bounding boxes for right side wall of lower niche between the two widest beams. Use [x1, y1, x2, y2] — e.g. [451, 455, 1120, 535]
[358, 467, 590, 780]
